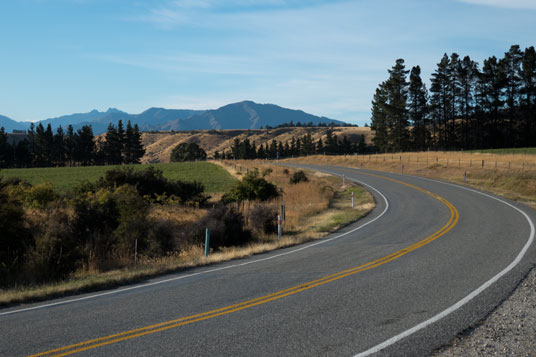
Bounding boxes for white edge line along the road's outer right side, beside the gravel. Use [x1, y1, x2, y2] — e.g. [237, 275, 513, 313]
[355, 169, 535, 357]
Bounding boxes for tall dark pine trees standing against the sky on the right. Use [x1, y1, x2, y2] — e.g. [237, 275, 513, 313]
[371, 45, 536, 151]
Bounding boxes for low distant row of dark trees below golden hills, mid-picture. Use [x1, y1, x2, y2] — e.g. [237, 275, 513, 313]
[214, 129, 368, 160]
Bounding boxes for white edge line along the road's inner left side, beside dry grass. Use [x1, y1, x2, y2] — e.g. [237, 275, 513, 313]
[0, 170, 389, 316]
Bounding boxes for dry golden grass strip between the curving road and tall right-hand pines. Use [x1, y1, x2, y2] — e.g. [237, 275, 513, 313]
[289, 152, 536, 208]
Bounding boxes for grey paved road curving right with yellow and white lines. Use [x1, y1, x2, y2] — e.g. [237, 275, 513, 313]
[0, 167, 536, 356]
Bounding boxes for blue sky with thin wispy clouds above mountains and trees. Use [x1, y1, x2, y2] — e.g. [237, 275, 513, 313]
[0, 0, 536, 125]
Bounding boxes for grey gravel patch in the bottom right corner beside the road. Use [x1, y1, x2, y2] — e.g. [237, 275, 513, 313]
[433, 268, 536, 357]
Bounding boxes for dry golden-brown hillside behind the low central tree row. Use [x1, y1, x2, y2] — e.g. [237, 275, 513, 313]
[141, 127, 372, 163]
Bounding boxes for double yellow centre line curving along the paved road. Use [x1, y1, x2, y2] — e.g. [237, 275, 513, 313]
[28, 169, 459, 357]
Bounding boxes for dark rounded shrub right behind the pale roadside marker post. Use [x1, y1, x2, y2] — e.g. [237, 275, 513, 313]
[190, 205, 251, 249]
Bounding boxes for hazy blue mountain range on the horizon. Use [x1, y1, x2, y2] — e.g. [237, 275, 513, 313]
[0, 101, 345, 135]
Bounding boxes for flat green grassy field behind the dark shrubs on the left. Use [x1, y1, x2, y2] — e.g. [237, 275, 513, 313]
[0, 162, 236, 193]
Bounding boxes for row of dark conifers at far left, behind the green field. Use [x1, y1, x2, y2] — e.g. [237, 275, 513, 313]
[0, 120, 145, 168]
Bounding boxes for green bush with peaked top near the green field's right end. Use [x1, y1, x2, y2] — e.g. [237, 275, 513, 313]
[222, 169, 279, 203]
